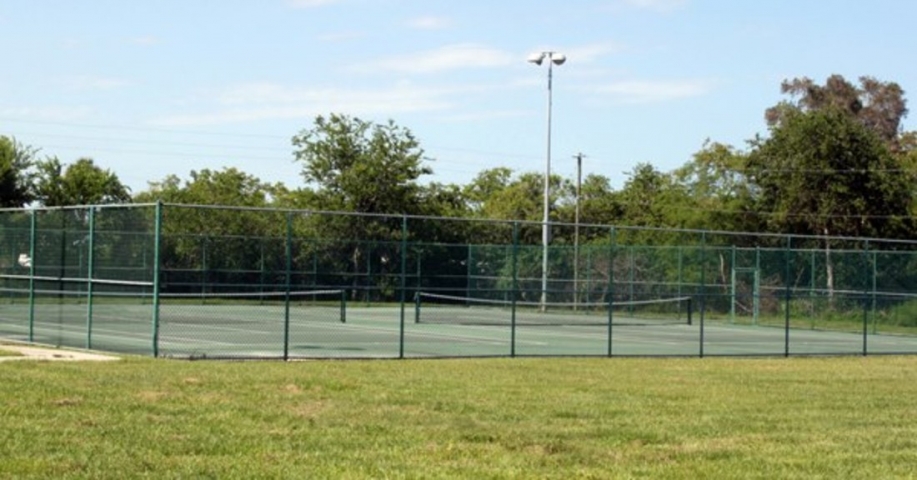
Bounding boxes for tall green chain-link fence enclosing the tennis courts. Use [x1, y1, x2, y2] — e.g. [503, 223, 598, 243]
[0, 204, 917, 359]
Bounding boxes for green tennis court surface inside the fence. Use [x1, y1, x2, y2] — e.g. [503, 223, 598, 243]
[0, 302, 917, 358]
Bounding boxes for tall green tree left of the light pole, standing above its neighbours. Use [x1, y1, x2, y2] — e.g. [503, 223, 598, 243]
[292, 114, 432, 294]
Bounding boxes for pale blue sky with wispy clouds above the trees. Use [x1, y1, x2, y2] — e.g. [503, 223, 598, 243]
[0, 0, 917, 193]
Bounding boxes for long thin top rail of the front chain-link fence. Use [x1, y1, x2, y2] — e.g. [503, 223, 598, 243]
[0, 202, 917, 247]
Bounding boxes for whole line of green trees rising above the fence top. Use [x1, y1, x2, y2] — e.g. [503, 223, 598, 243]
[0, 75, 917, 244]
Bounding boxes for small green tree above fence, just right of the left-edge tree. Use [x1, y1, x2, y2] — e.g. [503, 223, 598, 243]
[35, 158, 131, 207]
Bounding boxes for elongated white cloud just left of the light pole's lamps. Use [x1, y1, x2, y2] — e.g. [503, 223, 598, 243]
[353, 44, 519, 73]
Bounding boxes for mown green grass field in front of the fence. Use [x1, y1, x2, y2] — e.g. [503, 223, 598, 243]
[0, 357, 917, 479]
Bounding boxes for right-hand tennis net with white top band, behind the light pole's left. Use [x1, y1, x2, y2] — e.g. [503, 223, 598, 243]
[414, 292, 692, 326]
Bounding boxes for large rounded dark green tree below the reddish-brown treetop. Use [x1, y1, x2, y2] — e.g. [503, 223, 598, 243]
[748, 108, 911, 237]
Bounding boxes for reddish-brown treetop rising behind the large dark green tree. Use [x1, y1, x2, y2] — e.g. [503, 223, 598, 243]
[765, 75, 907, 152]
